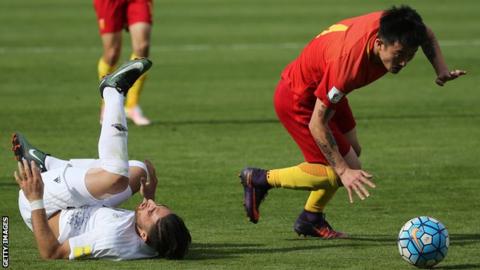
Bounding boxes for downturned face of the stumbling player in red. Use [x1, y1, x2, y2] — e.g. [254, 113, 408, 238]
[378, 41, 418, 74]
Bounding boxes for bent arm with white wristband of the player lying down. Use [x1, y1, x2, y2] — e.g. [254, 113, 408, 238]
[14, 160, 70, 259]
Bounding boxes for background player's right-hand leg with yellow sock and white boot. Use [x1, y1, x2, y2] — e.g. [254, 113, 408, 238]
[125, 22, 152, 126]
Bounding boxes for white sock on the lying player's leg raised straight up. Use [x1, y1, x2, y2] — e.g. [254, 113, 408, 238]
[98, 87, 128, 177]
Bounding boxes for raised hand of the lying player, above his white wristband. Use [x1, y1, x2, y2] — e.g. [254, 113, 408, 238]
[13, 160, 43, 202]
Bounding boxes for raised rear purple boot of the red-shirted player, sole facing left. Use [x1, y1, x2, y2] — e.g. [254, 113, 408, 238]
[239, 168, 270, 223]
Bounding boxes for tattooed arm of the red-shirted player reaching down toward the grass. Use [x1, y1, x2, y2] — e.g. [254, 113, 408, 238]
[309, 99, 375, 203]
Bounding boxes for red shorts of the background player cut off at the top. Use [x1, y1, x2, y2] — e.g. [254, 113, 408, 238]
[93, 0, 153, 34]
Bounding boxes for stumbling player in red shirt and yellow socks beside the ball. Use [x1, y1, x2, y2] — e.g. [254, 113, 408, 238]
[240, 6, 466, 239]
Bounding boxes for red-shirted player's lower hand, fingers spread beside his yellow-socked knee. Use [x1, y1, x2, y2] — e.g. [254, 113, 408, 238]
[340, 169, 375, 203]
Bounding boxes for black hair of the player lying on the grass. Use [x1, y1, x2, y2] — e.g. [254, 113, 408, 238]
[146, 214, 192, 260]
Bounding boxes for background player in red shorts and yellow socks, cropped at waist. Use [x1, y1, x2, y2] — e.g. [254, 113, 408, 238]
[93, 0, 153, 126]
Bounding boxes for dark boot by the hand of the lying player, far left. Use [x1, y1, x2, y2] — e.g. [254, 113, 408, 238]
[12, 132, 48, 172]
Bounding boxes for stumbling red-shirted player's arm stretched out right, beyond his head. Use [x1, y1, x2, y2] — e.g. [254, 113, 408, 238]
[422, 27, 467, 86]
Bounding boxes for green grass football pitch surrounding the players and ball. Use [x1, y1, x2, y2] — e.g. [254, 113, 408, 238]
[0, 0, 480, 269]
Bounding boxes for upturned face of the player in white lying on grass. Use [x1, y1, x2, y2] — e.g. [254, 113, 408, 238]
[135, 200, 172, 229]
